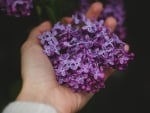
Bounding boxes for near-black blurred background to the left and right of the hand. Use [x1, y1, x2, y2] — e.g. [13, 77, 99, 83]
[0, 0, 150, 113]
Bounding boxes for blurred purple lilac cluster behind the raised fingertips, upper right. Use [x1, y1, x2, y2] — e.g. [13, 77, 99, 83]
[102, 0, 126, 39]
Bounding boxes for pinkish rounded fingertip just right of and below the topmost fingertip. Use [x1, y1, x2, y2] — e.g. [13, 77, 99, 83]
[105, 17, 117, 32]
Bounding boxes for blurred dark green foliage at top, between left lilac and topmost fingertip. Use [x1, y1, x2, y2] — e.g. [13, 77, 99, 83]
[33, 0, 80, 23]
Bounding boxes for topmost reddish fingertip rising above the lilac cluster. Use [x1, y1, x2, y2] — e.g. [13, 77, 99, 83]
[86, 2, 103, 20]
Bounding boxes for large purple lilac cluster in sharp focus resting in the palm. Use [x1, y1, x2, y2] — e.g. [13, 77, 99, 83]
[38, 14, 133, 93]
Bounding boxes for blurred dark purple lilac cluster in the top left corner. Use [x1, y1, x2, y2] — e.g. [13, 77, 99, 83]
[0, 0, 33, 17]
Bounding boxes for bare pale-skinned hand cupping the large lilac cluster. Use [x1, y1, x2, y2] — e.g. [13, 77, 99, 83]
[17, 2, 116, 113]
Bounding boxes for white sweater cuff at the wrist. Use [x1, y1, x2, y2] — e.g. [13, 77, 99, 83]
[2, 101, 57, 113]
